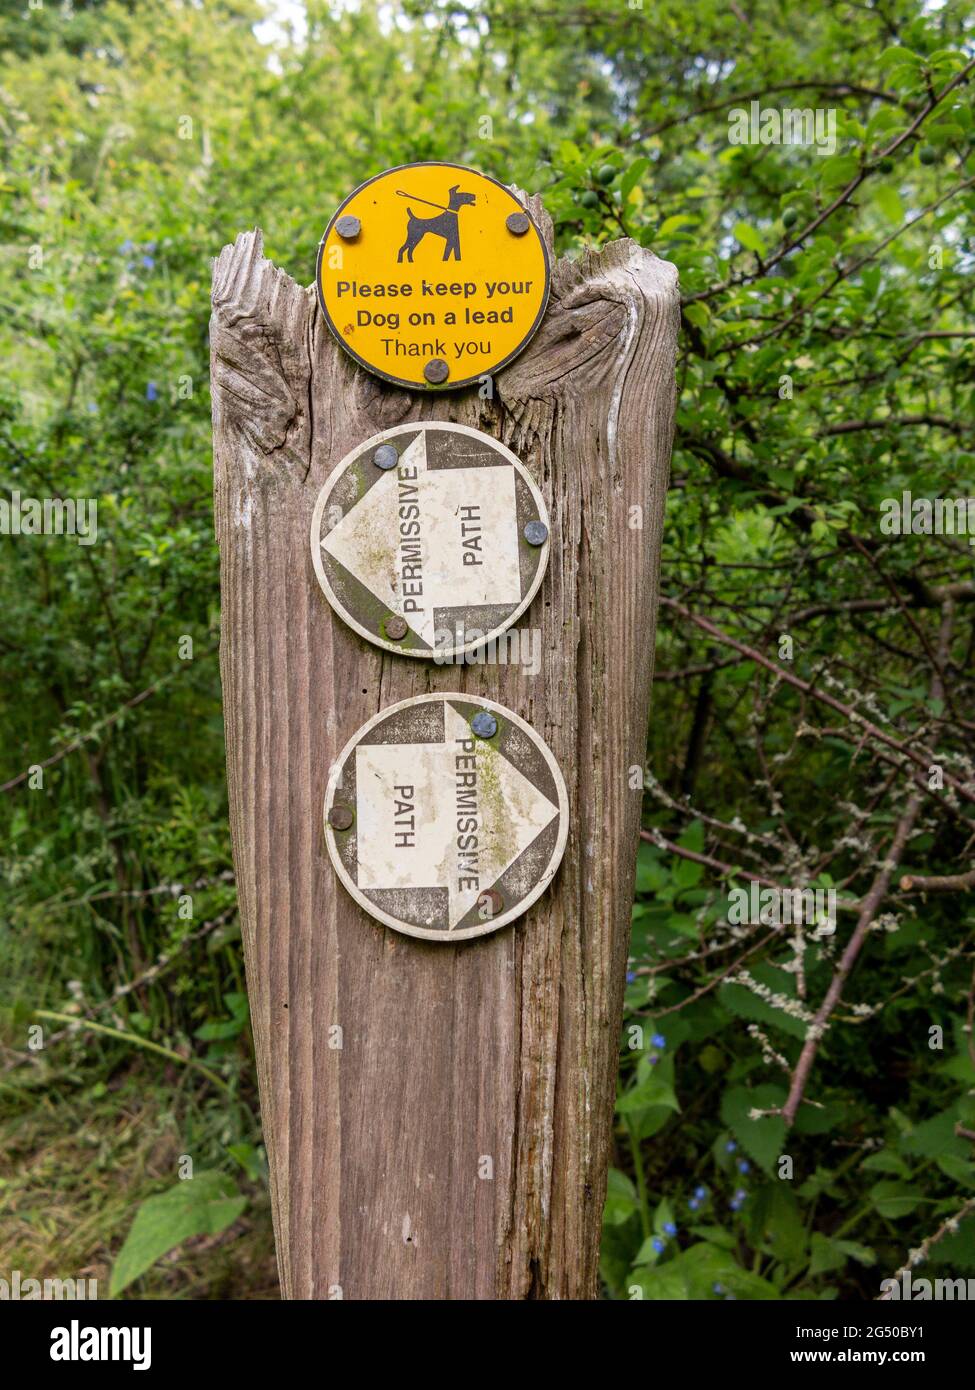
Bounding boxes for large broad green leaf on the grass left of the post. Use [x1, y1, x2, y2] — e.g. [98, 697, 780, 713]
[108, 1170, 248, 1298]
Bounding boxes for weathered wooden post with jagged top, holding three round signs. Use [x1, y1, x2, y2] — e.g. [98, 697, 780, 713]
[210, 195, 679, 1300]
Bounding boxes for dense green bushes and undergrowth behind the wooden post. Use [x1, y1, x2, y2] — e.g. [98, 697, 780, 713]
[0, 0, 975, 1298]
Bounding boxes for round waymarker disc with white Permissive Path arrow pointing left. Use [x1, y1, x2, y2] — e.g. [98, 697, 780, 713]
[312, 420, 551, 660]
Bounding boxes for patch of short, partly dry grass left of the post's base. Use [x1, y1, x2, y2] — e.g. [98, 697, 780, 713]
[0, 1041, 280, 1300]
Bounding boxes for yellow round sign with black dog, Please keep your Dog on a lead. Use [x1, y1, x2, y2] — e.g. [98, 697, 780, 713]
[316, 163, 549, 391]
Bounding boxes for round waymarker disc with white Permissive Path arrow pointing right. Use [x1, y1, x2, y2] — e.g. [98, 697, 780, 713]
[324, 694, 569, 942]
